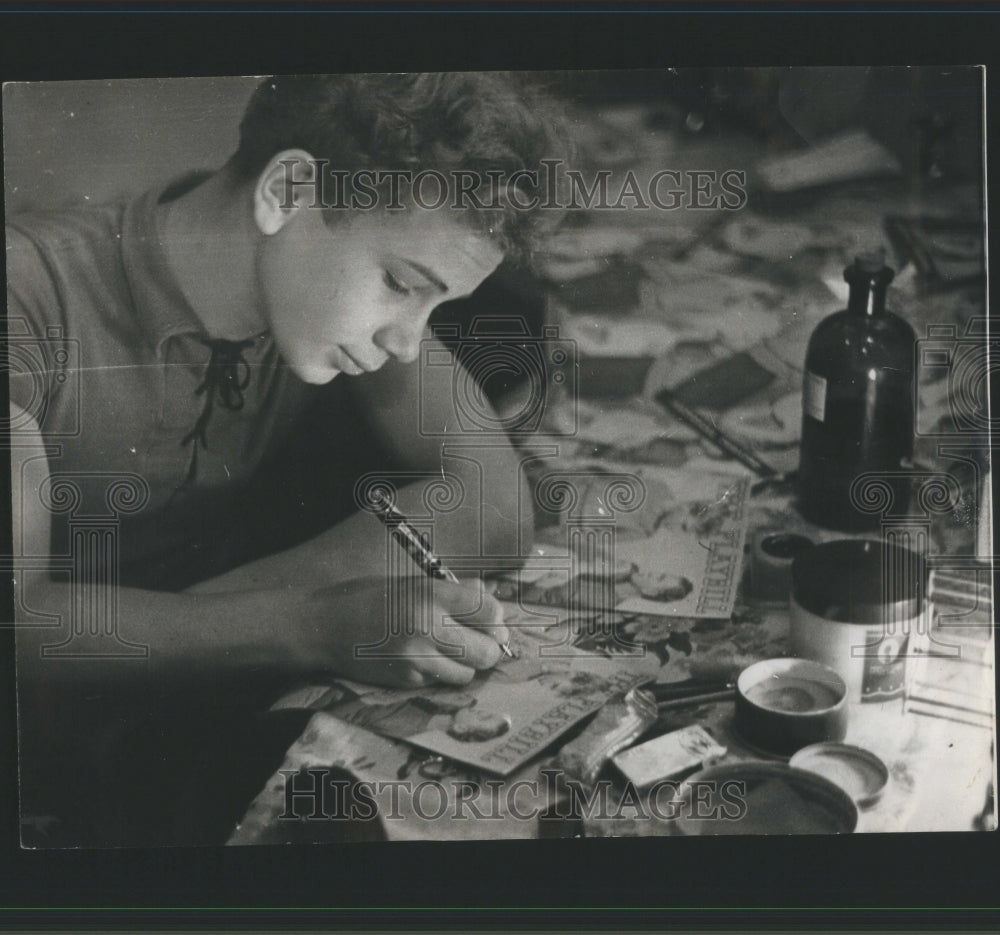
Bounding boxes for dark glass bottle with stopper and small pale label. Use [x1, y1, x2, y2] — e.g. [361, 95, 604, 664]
[799, 250, 916, 530]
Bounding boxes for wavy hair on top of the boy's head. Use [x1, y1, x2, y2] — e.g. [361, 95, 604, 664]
[230, 72, 568, 258]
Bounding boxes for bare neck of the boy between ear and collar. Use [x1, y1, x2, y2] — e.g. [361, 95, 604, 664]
[157, 169, 267, 341]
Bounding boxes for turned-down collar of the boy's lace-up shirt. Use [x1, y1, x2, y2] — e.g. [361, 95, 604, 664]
[122, 173, 214, 352]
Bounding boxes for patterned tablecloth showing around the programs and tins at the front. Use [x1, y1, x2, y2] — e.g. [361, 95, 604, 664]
[230, 472, 994, 844]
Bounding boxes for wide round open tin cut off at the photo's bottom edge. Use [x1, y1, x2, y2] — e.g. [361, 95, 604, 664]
[671, 760, 858, 836]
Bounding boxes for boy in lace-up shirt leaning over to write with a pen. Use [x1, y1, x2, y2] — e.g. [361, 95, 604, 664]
[6, 74, 557, 844]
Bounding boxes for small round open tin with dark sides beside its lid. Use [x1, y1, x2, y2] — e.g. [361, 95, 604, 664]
[735, 659, 847, 756]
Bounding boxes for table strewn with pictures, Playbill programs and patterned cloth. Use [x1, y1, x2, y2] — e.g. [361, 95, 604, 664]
[230, 108, 994, 844]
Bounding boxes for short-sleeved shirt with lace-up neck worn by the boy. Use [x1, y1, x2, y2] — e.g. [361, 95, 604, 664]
[7, 177, 316, 590]
